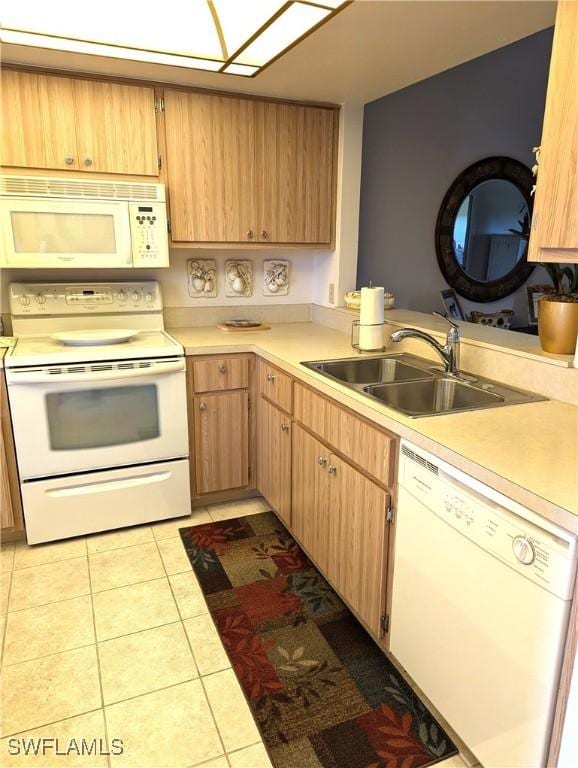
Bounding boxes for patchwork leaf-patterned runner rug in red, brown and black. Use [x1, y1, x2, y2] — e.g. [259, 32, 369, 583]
[180, 512, 457, 768]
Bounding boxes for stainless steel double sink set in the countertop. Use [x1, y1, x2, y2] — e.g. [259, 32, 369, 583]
[303, 353, 546, 418]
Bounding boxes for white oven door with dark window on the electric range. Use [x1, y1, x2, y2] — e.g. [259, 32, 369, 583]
[6, 358, 189, 480]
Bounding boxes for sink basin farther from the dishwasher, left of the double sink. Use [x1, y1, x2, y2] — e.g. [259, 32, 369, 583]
[309, 357, 433, 384]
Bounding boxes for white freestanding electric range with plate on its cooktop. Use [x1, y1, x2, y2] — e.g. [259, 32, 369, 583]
[4, 282, 191, 544]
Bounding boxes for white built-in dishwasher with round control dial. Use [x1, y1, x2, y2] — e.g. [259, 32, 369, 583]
[390, 441, 576, 768]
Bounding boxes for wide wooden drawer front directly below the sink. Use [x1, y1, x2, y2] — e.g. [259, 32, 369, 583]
[294, 383, 395, 486]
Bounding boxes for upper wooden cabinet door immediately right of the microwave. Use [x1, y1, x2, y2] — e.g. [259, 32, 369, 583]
[165, 90, 255, 242]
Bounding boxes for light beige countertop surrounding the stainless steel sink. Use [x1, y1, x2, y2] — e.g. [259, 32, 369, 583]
[168, 323, 578, 533]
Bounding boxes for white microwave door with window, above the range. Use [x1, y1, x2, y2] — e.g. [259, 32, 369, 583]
[0, 198, 132, 268]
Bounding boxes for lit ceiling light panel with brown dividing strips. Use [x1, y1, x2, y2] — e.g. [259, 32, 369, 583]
[2, 0, 349, 77]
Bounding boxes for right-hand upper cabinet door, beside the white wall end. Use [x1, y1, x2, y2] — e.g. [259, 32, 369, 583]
[255, 102, 336, 243]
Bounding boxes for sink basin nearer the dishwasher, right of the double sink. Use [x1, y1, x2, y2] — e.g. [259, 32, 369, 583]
[363, 377, 505, 416]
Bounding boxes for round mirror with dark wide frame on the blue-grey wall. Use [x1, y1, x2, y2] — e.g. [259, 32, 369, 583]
[435, 157, 535, 302]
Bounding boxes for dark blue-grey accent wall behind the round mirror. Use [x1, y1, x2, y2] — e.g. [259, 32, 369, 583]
[357, 28, 553, 325]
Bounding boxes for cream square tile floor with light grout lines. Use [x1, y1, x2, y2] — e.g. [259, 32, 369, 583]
[0, 499, 464, 768]
